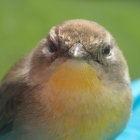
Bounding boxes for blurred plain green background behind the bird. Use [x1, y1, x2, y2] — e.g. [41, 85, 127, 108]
[0, 0, 140, 79]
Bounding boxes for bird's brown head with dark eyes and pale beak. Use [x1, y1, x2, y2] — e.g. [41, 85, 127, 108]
[31, 20, 129, 88]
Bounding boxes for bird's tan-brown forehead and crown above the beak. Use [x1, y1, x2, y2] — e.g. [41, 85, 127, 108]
[54, 20, 111, 49]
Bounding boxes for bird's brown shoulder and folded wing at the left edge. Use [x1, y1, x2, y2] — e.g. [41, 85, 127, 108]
[0, 52, 30, 136]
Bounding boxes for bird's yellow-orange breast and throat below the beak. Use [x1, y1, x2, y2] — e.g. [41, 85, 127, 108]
[29, 60, 132, 140]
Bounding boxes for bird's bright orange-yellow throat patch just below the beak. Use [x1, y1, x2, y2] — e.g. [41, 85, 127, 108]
[49, 60, 101, 93]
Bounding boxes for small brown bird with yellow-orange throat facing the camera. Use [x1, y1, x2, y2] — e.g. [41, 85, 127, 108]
[0, 19, 133, 140]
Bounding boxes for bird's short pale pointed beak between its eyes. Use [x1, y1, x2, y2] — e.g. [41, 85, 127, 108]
[69, 43, 87, 58]
